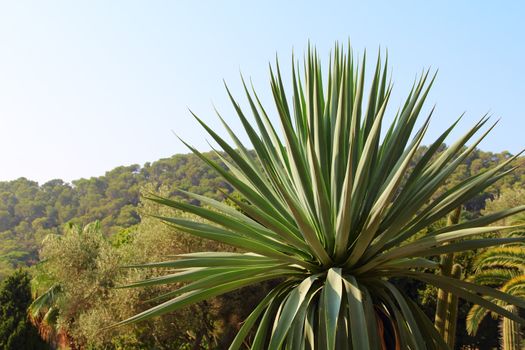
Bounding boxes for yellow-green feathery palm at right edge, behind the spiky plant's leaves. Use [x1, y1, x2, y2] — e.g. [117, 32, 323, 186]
[467, 245, 525, 350]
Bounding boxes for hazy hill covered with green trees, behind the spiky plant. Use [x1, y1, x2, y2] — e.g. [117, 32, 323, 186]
[0, 151, 525, 279]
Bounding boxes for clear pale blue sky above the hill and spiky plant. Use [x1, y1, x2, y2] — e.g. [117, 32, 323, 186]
[0, 0, 525, 183]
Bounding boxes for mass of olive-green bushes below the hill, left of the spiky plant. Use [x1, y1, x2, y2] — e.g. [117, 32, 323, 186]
[30, 186, 266, 349]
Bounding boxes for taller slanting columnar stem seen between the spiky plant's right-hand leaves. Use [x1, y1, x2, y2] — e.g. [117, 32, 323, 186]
[434, 207, 461, 339]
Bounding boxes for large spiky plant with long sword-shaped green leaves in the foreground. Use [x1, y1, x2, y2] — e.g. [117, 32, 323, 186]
[121, 46, 525, 350]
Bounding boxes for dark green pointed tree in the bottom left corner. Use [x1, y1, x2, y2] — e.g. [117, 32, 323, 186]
[0, 270, 47, 350]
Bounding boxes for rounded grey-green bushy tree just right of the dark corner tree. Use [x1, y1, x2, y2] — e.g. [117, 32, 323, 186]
[30, 222, 119, 346]
